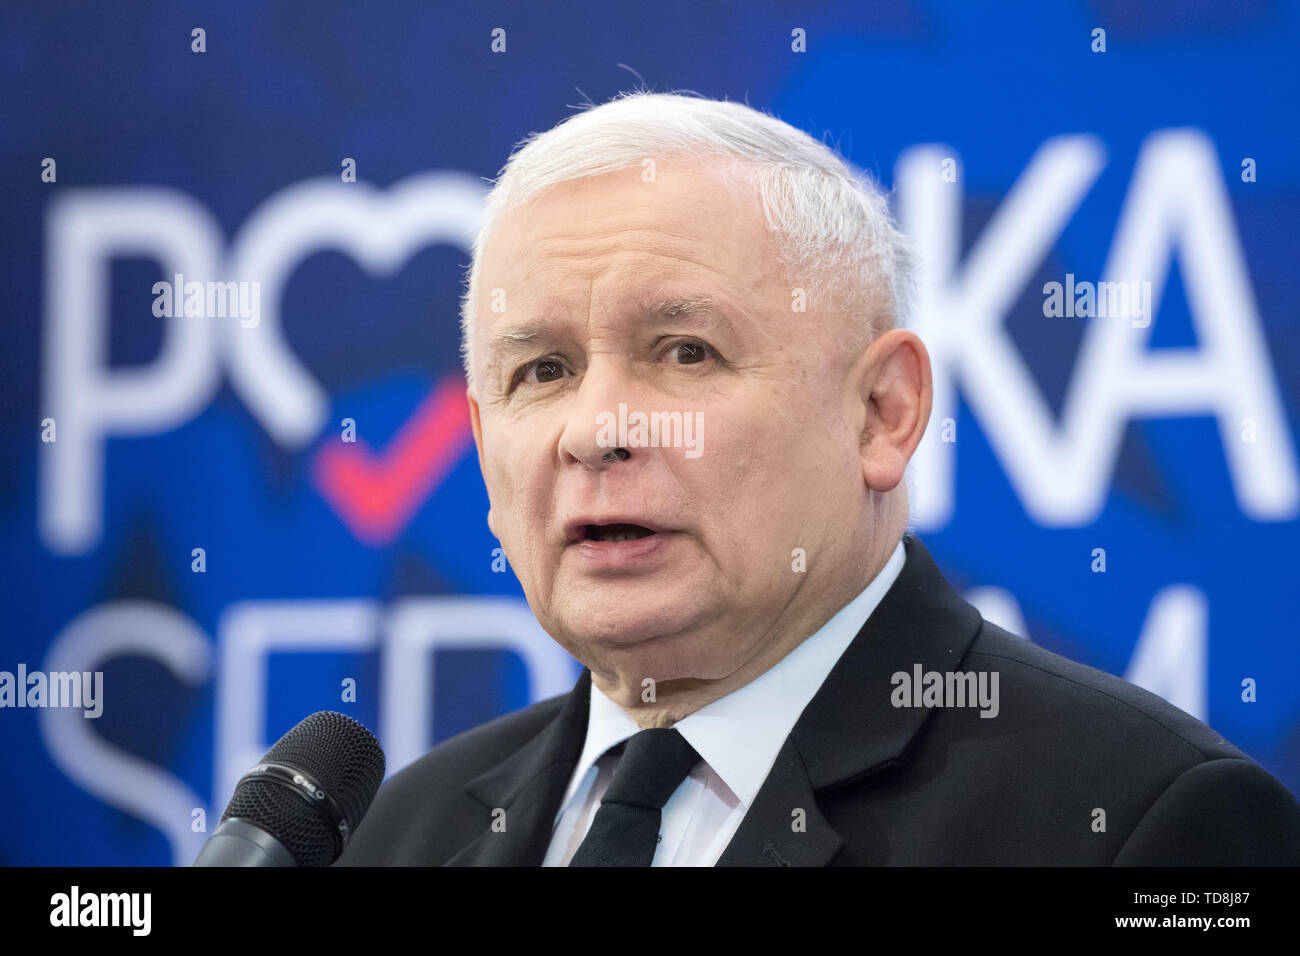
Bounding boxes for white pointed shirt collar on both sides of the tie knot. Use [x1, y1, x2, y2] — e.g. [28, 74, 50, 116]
[556, 541, 906, 819]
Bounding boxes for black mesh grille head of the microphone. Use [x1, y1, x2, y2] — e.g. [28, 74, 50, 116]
[221, 710, 384, 866]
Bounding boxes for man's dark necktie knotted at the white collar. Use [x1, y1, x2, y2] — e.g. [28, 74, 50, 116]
[569, 727, 699, 866]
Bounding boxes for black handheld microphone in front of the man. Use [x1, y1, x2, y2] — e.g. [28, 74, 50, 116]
[194, 710, 384, 866]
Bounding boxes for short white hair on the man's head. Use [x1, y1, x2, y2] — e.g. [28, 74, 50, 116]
[460, 91, 915, 382]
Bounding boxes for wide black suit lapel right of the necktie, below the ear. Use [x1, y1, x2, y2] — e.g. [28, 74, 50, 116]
[718, 536, 983, 866]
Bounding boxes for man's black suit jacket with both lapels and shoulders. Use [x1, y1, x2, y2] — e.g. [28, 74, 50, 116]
[338, 536, 1300, 866]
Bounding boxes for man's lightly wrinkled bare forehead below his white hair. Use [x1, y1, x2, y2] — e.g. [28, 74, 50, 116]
[478, 157, 776, 312]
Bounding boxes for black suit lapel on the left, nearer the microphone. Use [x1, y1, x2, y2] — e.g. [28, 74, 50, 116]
[446, 667, 592, 866]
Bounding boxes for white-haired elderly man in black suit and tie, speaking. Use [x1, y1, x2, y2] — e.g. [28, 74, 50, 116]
[341, 94, 1300, 866]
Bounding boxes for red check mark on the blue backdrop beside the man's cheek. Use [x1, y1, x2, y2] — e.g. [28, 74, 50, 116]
[312, 377, 473, 545]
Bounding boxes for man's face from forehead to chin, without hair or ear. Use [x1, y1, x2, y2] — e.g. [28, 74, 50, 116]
[471, 160, 866, 685]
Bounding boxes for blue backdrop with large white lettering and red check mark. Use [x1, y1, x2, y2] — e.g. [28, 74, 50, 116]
[0, 0, 1300, 865]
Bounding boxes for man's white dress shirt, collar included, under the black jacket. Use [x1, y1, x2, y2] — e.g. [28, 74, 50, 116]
[542, 541, 906, 866]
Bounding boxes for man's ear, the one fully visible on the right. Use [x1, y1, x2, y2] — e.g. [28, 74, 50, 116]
[849, 329, 935, 493]
